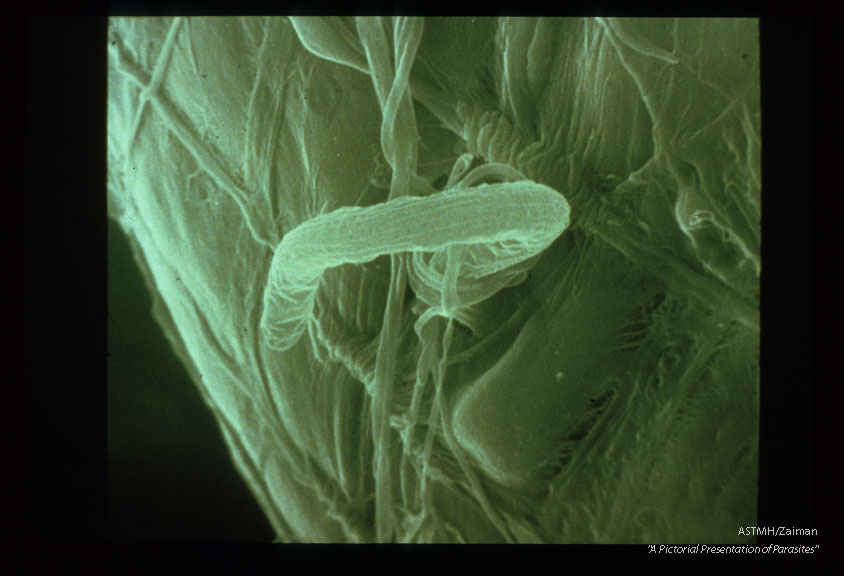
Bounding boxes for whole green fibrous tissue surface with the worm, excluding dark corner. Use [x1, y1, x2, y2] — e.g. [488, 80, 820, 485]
[107, 17, 761, 544]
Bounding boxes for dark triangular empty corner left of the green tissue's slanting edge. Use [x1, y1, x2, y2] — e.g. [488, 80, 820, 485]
[107, 220, 274, 542]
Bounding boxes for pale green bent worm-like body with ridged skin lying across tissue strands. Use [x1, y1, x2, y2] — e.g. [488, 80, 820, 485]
[261, 181, 569, 350]
